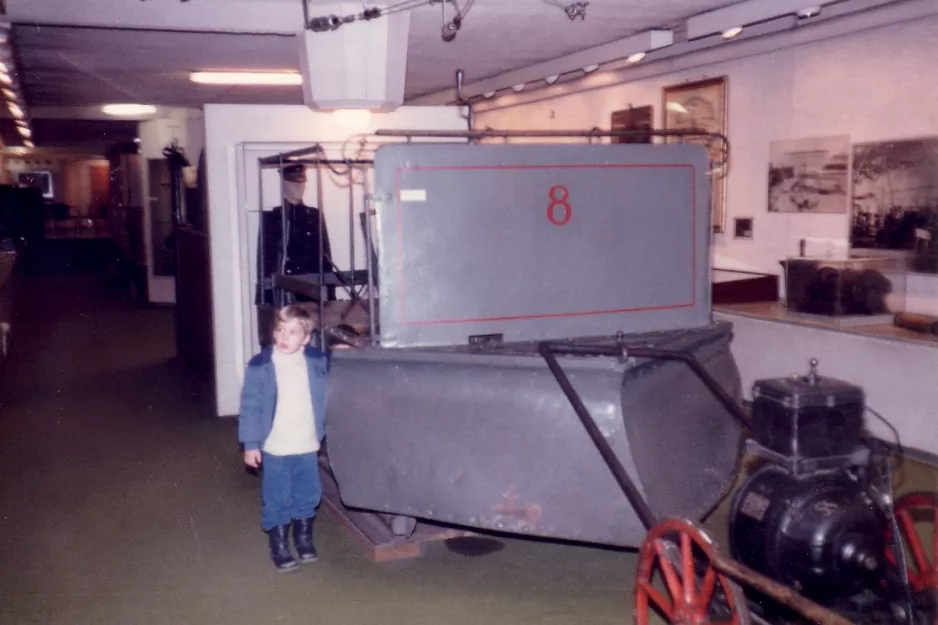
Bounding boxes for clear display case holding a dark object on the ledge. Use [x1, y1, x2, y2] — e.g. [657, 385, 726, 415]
[782, 256, 907, 324]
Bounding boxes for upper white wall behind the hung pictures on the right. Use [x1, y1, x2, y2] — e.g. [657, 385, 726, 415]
[475, 15, 938, 288]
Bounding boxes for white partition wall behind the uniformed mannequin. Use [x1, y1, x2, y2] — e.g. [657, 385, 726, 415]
[205, 105, 466, 416]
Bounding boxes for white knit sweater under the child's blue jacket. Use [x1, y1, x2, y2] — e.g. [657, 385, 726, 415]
[264, 347, 319, 456]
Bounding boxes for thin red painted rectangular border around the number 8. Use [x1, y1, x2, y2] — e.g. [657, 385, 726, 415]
[395, 163, 697, 326]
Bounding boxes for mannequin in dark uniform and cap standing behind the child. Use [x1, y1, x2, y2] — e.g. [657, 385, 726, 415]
[256, 164, 335, 305]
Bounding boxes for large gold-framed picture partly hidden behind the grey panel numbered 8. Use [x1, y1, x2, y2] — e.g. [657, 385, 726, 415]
[662, 76, 727, 232]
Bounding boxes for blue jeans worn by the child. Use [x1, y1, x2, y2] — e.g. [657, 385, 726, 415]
[261, 452, 322, 532]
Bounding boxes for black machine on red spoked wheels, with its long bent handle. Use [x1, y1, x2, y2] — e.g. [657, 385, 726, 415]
[540, 343, 938, 625]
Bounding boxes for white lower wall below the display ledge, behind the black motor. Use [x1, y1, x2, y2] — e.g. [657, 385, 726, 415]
[716, 313, 938, 455]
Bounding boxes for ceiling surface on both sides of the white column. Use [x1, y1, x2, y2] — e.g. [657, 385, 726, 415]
[7, 0, 733, 107]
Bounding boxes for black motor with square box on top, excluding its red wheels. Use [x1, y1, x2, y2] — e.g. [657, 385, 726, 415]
[730, 361, 924, 624]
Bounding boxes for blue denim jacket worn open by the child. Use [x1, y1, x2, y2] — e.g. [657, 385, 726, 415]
[238, 346, 329, 451]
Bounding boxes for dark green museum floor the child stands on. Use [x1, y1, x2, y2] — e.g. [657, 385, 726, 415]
[0, 274, 938, 625]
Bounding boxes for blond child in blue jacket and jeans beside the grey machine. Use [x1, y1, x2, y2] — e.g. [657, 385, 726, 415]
[238, 306, 329, 571]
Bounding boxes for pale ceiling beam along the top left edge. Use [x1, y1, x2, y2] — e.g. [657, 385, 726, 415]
[2, 0, 303, 35]
